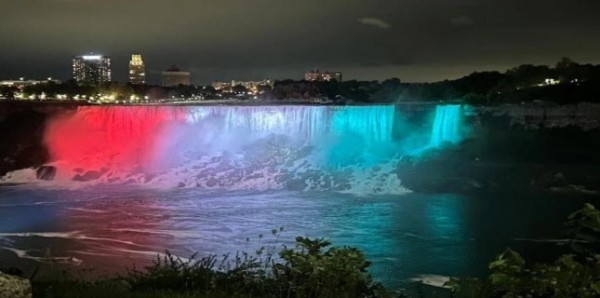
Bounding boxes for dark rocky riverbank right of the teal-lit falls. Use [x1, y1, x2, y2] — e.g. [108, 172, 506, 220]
[398, 114, 600, 195]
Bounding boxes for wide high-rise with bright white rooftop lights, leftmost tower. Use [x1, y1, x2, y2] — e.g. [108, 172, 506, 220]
[73, 55, 111, 84]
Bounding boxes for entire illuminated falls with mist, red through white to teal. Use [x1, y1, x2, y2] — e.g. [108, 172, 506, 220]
[2, 105, 461, 193]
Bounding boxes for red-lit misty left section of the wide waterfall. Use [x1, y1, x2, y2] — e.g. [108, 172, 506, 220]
[45, 107, 186, 169]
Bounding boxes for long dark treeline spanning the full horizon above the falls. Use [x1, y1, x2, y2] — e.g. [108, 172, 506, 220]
[0, 58, 600, 104]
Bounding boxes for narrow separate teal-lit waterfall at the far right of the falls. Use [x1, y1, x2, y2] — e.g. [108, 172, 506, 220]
[429, 105, 462, 147]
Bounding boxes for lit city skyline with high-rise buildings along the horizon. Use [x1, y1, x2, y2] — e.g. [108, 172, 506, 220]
[0, 53, 341, 104]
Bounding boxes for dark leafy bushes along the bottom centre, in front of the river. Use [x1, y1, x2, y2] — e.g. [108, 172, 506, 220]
[34, 234, 391, 298]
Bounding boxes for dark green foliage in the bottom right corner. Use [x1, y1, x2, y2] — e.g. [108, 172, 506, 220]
[449, 204, 600, 297]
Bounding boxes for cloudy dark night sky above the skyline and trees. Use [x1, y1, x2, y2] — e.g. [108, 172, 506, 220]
[0, 0, 600, 83]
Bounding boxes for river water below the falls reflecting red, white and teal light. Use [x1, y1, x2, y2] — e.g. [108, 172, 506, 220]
[0, 187, 586, 285]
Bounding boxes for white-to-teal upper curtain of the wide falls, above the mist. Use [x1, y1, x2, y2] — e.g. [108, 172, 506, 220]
[187, 106, 394, 142]
